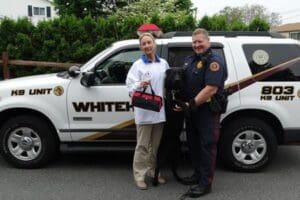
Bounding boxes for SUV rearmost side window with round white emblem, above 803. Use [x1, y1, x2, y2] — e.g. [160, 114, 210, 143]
[243, 44, 300, 81]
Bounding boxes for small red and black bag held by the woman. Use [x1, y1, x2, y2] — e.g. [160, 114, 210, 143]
[131, 85, 162, 112]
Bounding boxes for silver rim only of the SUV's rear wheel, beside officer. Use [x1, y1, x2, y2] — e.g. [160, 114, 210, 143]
[232, 130, 267, 165]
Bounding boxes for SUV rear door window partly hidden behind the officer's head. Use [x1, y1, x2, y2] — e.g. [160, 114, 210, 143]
[168, 47, 226, 67]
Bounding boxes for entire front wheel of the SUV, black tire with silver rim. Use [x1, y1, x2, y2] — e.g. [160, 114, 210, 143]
[0, 115, 58, 169]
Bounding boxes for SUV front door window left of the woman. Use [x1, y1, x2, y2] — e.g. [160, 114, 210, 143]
[95, 49, 142, 85]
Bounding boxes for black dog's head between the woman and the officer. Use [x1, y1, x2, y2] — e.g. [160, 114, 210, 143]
[165, 67, 184, 91]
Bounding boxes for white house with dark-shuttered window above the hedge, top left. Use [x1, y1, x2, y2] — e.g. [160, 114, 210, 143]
[0, 0, 57, 24]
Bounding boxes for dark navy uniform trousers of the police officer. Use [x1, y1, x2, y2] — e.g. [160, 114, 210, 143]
[186, 106, 220, 186]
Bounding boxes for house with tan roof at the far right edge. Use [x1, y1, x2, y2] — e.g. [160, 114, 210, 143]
[270, 22, 300, 40]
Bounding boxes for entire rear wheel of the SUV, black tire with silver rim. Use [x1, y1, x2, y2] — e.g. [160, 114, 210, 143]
[219, 118, 277, 172]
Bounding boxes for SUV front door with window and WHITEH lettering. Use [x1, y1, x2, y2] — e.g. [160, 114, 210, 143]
[67, 46, 141, 141]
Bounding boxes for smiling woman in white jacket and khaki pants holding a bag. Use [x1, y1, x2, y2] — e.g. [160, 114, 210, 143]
[126, 33, 169, 189]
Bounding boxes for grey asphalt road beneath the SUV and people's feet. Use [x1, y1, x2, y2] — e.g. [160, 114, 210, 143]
[0, 146, 300, 200]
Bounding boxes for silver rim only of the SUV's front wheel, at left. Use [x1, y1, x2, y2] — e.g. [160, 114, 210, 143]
[8, 127, 42, 161]
